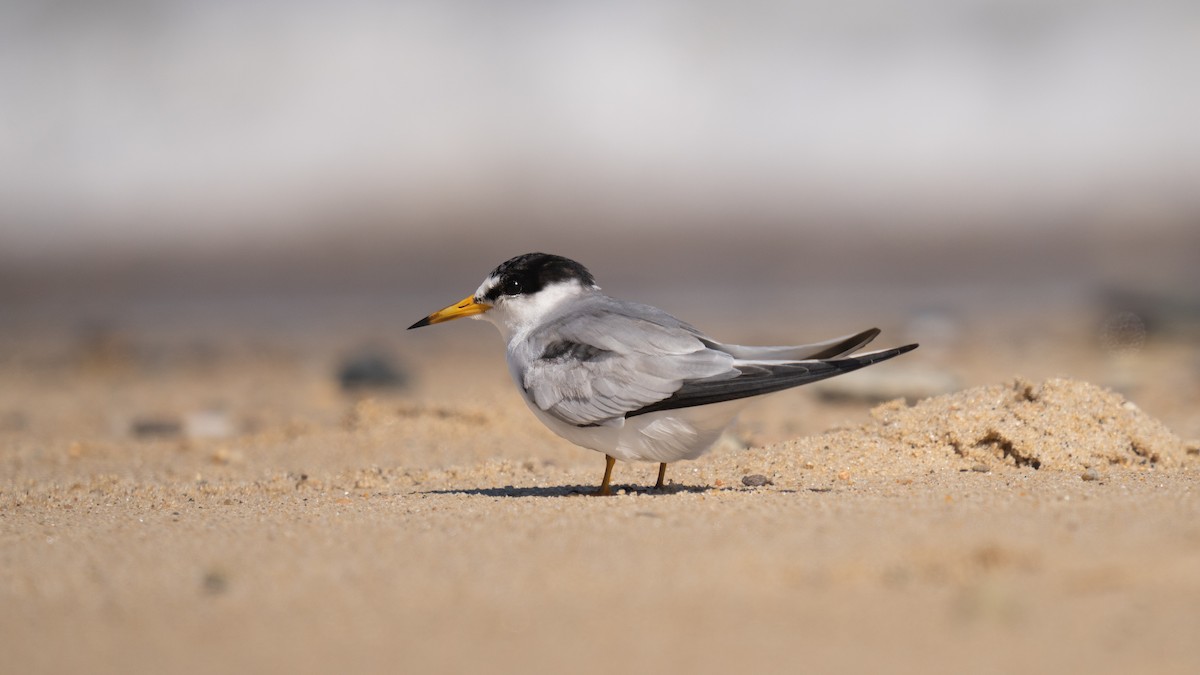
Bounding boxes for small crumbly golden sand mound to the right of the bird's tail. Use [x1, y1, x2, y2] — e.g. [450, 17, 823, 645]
[863, 378, 1195, 471]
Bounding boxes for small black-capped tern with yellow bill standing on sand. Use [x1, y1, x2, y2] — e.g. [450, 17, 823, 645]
[408, 252, 918, 495]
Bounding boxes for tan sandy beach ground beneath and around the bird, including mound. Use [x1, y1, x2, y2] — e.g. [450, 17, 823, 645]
[0, 309, 1200, 674]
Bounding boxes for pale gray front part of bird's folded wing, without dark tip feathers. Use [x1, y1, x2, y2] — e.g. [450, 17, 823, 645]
[521, 300, 738, 426]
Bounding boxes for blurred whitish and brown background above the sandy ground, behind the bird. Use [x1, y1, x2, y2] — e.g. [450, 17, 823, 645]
[0, 0, 1200, 434]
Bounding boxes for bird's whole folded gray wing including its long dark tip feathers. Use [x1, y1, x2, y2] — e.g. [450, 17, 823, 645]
[516, 298, 917, 426]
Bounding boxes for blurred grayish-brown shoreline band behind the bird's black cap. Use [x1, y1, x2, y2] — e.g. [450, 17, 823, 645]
[0, 223, 1200, 331]
